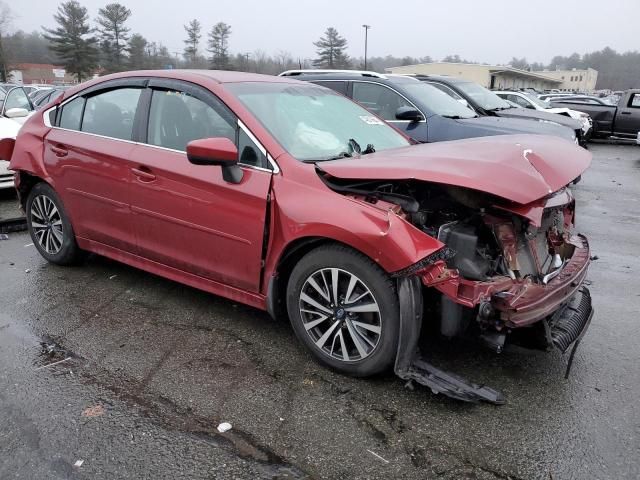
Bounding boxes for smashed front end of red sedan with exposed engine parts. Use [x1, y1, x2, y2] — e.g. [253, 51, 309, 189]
[419, 189, 593, 351]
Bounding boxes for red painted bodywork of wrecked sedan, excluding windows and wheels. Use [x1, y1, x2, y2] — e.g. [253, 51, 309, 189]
[10, 71, 590, 323]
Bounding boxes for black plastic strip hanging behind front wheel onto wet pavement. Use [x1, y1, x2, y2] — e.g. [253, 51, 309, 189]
[395, 276, 505, 405]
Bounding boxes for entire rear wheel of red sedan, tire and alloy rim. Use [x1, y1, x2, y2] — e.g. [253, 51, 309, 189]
[26, 183, 82, 265]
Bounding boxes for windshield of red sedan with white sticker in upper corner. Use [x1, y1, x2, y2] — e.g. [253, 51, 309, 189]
[226, 82, 410, 161]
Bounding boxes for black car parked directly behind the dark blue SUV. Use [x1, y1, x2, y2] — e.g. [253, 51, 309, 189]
[414, 75, 584, 144]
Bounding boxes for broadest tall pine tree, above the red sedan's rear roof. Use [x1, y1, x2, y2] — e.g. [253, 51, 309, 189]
[44, 0, 98, 82]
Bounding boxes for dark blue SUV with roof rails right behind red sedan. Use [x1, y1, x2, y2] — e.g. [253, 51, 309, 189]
[280, 70, 576, 142]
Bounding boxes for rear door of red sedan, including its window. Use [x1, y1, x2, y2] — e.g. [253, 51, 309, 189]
[44, 80, 144, 252]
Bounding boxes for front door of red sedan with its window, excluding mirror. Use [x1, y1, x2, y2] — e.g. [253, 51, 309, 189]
[131, 79, 273, 292]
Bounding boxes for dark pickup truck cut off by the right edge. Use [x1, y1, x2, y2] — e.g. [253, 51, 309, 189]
[549, 89, 640, 140]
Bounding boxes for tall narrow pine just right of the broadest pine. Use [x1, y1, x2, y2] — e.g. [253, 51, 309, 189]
[97, 3, 131, 72]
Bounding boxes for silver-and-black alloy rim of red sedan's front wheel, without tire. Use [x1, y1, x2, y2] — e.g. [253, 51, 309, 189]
[299, 268, 382, 362]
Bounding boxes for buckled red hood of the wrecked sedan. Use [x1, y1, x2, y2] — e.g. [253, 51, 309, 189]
[317, 135, 591, 205]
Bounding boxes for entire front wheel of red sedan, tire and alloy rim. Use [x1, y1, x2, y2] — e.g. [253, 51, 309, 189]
[287, 245, 398, 376]
